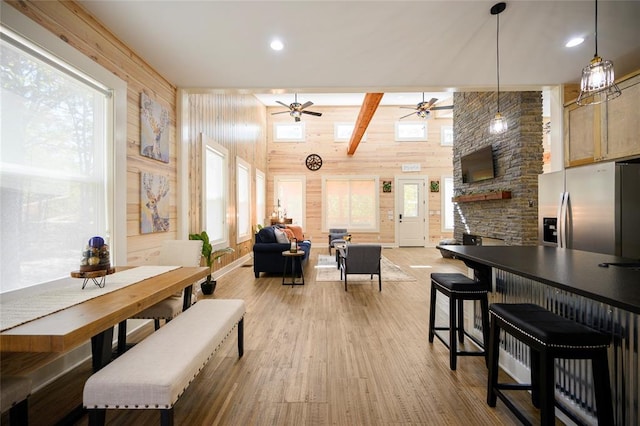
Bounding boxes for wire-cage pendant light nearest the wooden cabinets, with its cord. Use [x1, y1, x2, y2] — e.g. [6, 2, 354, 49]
[577, 0, 620, 105]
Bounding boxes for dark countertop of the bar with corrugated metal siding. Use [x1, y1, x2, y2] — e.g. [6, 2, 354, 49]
[437, 245, 640, 314]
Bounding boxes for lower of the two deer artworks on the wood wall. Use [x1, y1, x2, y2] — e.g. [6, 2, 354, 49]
[140, 172, 169, 234]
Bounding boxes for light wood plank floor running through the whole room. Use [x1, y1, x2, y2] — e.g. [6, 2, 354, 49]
[3, 247, 556, 425]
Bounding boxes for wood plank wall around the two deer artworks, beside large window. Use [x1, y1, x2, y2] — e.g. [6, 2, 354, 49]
[8, 0, 178, 264]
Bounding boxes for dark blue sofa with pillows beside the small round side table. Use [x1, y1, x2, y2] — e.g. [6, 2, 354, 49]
[253, 225, 311, 278]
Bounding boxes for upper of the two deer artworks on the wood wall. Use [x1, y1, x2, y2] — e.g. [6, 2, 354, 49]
[140, 93, 169, 163]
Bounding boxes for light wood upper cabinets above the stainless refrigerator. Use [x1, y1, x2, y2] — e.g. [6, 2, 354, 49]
[564, 71, 640, 167]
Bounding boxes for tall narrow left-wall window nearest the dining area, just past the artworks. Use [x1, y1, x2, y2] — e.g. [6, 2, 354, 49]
[202, 134, 229, 248]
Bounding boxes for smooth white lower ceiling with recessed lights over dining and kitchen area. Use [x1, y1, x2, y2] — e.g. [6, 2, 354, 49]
[79, 0, 640, 105]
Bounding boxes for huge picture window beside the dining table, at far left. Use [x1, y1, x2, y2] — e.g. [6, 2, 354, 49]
[0, 14, 126, 292]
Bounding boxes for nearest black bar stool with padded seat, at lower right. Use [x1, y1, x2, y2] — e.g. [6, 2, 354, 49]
[487, 303, 614, 425]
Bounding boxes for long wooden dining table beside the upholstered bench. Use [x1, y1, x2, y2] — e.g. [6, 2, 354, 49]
[0, 267, 209, 371]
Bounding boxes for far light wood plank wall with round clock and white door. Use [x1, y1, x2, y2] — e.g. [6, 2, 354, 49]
[267, 102, 453, 245]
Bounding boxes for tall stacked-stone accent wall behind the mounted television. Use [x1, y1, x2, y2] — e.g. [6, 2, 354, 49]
[453, 92, 543, 245]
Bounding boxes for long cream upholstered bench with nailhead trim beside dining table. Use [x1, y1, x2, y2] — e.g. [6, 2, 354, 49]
[83, 299, 245, 425]
